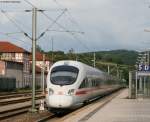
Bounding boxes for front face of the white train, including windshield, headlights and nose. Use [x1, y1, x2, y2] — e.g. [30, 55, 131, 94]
[46, 63, 79, 110]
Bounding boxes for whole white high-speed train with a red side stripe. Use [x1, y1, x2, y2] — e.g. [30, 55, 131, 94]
[46, 60, 121, 112]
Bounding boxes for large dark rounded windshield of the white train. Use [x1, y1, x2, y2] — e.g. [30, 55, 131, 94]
[50, 66, 79, 85]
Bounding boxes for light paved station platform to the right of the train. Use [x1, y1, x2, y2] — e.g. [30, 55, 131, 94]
[62, 89, 150, 122]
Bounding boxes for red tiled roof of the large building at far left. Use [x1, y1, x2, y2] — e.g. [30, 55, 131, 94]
[0, 41, 29, 53]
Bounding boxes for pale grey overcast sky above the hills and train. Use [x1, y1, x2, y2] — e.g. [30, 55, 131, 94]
[0, 0, 150, 52]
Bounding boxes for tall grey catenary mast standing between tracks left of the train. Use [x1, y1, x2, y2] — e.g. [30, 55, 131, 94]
[31, 8, 37, 113]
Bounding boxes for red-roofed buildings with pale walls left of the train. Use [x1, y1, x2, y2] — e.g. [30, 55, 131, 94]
[0, 41, 51, 88]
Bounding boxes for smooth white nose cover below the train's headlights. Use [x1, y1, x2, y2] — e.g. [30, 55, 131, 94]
[47, 95, 73, 108]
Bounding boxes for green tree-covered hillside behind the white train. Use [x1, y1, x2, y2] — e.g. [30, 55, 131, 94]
[46, 50, 138, 84]
